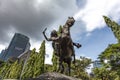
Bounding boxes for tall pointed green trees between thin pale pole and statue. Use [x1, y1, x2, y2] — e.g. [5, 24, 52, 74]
[22, 41, 45, 79]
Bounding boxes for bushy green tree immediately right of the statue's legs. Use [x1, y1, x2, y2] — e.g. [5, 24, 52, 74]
[72, 56, 92, 80]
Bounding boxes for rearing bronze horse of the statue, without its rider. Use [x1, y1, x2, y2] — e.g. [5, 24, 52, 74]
[58, 17, 81, 75]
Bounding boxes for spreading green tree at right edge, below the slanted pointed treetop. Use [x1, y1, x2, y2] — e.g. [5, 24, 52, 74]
[98, 43, 120, 78]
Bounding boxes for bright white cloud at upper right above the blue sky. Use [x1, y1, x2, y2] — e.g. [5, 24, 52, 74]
[74, 0, 120, 32]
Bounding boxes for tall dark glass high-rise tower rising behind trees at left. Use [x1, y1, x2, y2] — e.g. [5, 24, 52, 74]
[4, 33, 30, 61]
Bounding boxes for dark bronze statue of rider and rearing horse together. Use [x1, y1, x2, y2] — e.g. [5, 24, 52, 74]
[43, 17, 81, 75]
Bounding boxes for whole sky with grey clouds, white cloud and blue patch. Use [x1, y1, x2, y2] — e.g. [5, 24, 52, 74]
[0, 0, 120, 64]
